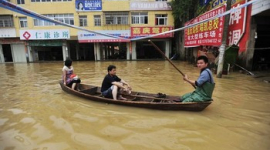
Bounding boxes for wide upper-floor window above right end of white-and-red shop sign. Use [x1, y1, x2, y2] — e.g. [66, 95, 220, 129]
[104, 12, 128, 25]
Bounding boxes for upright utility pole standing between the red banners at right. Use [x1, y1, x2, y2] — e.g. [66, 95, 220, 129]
[217, 0, 232, 78]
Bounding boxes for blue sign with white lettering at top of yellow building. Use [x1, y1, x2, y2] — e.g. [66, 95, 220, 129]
[75, 0, 102, 11]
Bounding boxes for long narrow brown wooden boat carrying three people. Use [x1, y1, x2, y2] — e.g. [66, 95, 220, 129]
[59, 81, 212, 111]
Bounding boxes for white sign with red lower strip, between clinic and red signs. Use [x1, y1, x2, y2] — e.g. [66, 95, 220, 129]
[78, 30, 130, 43]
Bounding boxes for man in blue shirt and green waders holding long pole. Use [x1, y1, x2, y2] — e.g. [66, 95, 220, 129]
[181, 56, 215, 102]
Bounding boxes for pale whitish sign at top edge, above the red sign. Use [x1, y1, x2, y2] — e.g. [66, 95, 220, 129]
[130, 1, 172, 10]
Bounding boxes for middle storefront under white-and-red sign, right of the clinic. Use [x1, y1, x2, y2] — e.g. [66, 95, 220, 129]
[78, 30, 130, 60]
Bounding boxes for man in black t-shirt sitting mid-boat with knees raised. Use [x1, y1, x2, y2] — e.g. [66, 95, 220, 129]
[101, 65, 131, 100]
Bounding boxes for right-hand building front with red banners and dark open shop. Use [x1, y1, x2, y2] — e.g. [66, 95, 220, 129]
[185, 0, 270, 70]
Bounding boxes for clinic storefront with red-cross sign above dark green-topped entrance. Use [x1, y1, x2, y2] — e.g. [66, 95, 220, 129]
[20, 29, 70, 62]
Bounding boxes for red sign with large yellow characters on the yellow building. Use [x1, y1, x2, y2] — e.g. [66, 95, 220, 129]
[131, 26, 173, 38]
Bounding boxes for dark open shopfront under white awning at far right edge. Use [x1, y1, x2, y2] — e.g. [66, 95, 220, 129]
[247, 0, 270, 71]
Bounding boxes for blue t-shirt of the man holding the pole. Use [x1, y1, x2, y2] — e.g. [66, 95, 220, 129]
[195, 68, 214, 86]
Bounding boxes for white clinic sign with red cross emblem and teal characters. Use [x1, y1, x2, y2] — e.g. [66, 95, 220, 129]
[20, 29, 70, 40]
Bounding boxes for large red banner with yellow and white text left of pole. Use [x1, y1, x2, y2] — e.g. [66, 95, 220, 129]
[185, 5, 226, 47]
